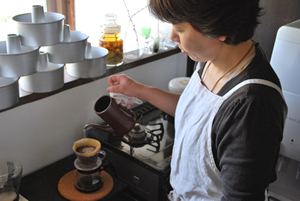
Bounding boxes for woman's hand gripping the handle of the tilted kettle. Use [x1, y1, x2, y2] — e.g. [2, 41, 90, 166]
[107, 74, 142, 98]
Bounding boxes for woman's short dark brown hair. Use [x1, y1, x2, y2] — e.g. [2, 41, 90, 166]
[149, 0, 262, 45]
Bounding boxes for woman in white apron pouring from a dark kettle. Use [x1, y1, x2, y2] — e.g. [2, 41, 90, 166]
[107, 0, 287, 201]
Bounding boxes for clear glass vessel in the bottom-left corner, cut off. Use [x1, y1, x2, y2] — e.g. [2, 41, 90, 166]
[0, 159, 22, 201]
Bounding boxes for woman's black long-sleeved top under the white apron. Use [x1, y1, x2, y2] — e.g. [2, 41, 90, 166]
[198, 44, 287, 201]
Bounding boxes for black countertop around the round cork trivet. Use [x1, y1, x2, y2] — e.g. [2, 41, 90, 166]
[19, 154, 126, 201]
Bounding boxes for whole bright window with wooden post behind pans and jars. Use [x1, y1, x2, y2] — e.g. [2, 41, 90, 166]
[0, 0, 171, 52]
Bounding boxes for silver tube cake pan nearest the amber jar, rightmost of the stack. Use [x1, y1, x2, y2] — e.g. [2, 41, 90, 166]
[66, 43, 108, 78]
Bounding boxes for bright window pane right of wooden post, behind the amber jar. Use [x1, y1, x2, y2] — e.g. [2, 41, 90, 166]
[75, 0, 171, 49]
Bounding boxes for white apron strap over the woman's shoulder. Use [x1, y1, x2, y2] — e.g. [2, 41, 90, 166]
[223, 79, 284, 100]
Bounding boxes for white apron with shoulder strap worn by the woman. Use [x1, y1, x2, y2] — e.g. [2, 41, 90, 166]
[169, 60, 282, 201]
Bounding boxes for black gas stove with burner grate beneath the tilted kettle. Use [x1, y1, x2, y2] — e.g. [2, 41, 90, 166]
[86, 102, 175, 201]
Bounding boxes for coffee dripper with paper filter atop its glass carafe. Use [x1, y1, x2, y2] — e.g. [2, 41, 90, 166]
[73, 138, 106, 192]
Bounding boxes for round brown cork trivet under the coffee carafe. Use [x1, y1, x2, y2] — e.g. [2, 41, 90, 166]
[58, 169, 114, 201]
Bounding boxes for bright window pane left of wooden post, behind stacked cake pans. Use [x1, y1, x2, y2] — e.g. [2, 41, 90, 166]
[0, 0, 47, 41]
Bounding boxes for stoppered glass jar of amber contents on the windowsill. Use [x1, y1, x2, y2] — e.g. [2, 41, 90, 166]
[99, 13, 123, 67]
